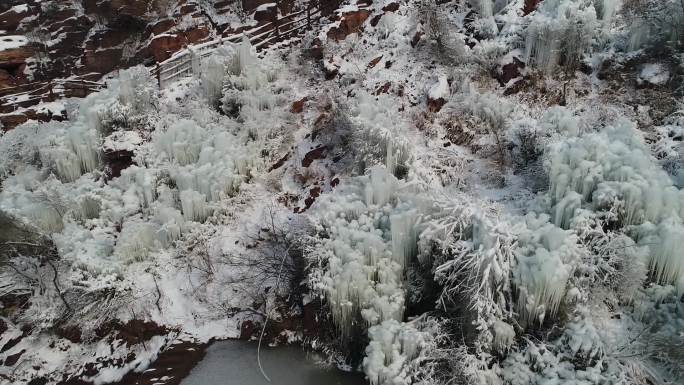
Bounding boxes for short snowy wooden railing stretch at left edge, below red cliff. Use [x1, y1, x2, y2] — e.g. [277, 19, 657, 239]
[0, 78, 105, 113]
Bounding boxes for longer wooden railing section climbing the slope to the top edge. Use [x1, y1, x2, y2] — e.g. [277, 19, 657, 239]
[152, 0, 350, 89]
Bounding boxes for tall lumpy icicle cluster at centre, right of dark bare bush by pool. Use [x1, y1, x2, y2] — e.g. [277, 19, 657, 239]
[310, 166, 419, 336]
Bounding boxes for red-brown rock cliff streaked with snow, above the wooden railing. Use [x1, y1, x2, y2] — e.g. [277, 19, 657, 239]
[0, 0, 251, 89]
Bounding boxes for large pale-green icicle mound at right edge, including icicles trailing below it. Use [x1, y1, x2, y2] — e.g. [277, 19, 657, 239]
[548, 121, 684, 296]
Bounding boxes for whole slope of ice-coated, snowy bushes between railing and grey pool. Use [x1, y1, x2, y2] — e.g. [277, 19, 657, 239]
[0, 0, 684, 385]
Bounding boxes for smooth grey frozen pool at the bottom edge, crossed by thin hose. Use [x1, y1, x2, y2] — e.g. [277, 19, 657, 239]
[181, 341, 366, 385]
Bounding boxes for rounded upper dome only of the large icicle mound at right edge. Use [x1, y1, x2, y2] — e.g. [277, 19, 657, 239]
[549, 121, 684, 225]
